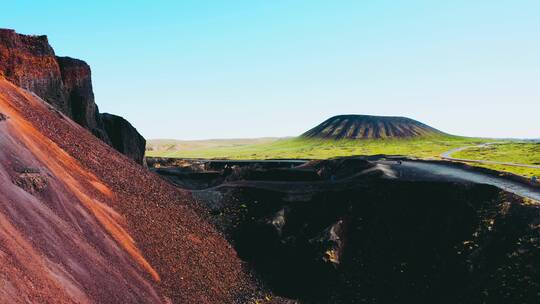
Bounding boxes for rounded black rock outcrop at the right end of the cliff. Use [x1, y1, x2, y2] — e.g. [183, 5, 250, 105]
[100, 113, 146, 163]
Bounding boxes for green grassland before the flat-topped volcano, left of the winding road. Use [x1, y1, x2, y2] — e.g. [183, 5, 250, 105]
[146, 135, 488, 159]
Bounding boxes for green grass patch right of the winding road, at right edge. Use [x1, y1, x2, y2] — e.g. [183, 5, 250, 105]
[452, 142, 540, 177]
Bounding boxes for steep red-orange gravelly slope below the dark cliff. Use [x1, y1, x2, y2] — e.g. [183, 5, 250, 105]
[0, 77, 250, 303]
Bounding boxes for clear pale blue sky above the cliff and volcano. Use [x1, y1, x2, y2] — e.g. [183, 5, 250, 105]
[0, 0, 540, 139]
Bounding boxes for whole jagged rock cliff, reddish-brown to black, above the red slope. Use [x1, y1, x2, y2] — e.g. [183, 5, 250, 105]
[0, 29, 145, 163]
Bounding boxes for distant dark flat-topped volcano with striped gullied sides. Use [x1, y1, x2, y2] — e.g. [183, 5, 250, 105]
[302, 115, 444, 139]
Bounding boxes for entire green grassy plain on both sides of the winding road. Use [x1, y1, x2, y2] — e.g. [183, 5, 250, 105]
[146, 135, 540, 177]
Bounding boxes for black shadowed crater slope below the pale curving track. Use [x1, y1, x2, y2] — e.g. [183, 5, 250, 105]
[151, 158, 540, 303]
